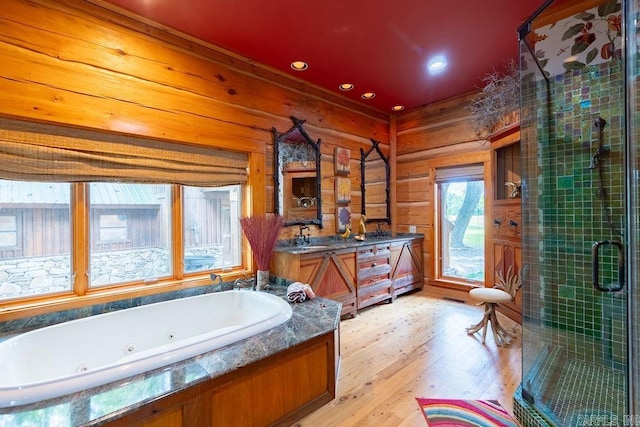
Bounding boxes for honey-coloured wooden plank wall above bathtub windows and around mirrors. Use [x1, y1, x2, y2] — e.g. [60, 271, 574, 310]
[0, 0, 390, 242]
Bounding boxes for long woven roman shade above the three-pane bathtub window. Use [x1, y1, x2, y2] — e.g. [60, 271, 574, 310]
[0, 119, 248, 187]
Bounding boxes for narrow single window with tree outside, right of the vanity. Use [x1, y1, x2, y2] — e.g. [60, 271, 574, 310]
[436, 166, 485, 285]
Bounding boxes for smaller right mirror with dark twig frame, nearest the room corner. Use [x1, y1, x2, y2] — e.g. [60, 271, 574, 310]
[360, 139, 391, 225]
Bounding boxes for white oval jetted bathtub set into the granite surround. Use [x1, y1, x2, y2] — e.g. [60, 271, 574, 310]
[0, 291, 292, 408]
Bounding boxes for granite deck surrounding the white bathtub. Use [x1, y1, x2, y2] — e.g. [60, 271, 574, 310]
[0, 289, 341, 426]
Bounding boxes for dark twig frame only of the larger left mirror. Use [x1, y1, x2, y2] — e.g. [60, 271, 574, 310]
[271, 116, 322, 228]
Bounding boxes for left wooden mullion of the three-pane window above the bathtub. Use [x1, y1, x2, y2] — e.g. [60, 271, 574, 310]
[71, 183, 90, 295]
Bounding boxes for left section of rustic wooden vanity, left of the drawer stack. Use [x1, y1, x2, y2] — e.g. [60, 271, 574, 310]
[271, 248, 357, 317]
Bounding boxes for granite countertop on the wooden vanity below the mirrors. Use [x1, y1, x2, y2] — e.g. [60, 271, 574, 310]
[275, 232, 424, 255]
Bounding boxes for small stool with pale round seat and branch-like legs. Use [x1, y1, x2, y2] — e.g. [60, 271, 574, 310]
[467, 288, 516, 346]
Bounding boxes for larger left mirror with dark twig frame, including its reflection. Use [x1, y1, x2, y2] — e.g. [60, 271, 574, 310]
[272, 117, 322, 228]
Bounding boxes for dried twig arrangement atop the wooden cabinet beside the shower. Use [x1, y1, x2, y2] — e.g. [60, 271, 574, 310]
[469, 61, 520, 138]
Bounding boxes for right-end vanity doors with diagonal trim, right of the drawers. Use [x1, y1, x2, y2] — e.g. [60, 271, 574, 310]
[390, 239, 424, 297]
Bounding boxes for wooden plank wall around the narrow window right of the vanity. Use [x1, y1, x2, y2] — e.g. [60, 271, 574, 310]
[394, 93, 490, 290]
